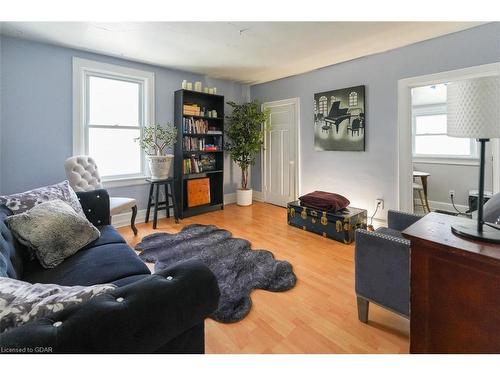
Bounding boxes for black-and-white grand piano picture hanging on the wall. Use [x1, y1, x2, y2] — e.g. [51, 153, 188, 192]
[314, 86, 366, 151]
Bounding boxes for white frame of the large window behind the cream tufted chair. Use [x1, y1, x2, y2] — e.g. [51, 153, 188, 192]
[73, 57, 155, 188]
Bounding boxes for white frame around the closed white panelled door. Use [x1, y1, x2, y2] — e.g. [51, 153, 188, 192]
[260, 98, 301, 202]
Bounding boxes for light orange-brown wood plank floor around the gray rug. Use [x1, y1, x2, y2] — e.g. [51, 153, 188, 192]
[120, 203, 409, 353]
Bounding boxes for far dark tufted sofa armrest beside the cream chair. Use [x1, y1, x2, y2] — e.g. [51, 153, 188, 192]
[76, 189, 111, 226]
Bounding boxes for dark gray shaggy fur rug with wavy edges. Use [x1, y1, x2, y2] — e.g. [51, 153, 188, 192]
[135, 224, 297, 323]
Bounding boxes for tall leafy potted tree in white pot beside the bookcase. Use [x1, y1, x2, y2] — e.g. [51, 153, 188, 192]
[225, 101, 269, 206]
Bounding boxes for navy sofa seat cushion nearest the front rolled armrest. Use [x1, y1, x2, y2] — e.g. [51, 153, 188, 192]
[23, 243, 150, 286]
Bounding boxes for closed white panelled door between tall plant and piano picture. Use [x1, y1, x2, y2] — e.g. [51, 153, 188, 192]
[263, 99, 298, 207]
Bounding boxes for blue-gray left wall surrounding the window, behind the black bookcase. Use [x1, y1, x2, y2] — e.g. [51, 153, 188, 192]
[0, 36, 249, 208]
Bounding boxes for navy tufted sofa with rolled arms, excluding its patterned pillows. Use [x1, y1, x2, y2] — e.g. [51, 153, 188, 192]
[0, 190, 219, 353]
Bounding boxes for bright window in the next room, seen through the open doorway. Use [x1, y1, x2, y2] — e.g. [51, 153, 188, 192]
[412, 104, 477, 159]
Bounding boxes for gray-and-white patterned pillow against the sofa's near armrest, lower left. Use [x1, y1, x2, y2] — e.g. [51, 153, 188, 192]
[0, 277, 116, 333]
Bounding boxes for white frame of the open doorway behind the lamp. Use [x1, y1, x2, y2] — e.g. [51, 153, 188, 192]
[397, 63, 500, 212]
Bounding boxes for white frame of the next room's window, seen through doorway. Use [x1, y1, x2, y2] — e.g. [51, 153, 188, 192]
[411, 103, 479, 165]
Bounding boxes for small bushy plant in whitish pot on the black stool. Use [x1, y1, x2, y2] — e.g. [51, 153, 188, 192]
[136, 123, 177, 180]
